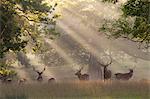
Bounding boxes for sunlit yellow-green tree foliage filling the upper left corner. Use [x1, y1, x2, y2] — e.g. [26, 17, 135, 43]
[0, 0, 59, 58]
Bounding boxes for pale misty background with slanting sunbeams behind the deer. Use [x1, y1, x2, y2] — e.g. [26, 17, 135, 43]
[0, 0, 150, 84]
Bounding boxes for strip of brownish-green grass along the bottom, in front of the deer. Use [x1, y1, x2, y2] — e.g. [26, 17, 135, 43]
[0, 81, 150, 99]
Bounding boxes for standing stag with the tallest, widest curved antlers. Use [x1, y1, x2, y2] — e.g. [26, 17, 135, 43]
[99, 57, 112, 81]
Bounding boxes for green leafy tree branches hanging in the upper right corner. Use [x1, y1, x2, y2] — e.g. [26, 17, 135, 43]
[100, 0, 150, 48]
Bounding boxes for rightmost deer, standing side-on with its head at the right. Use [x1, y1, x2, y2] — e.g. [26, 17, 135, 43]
[115, 69, 133, 80]
